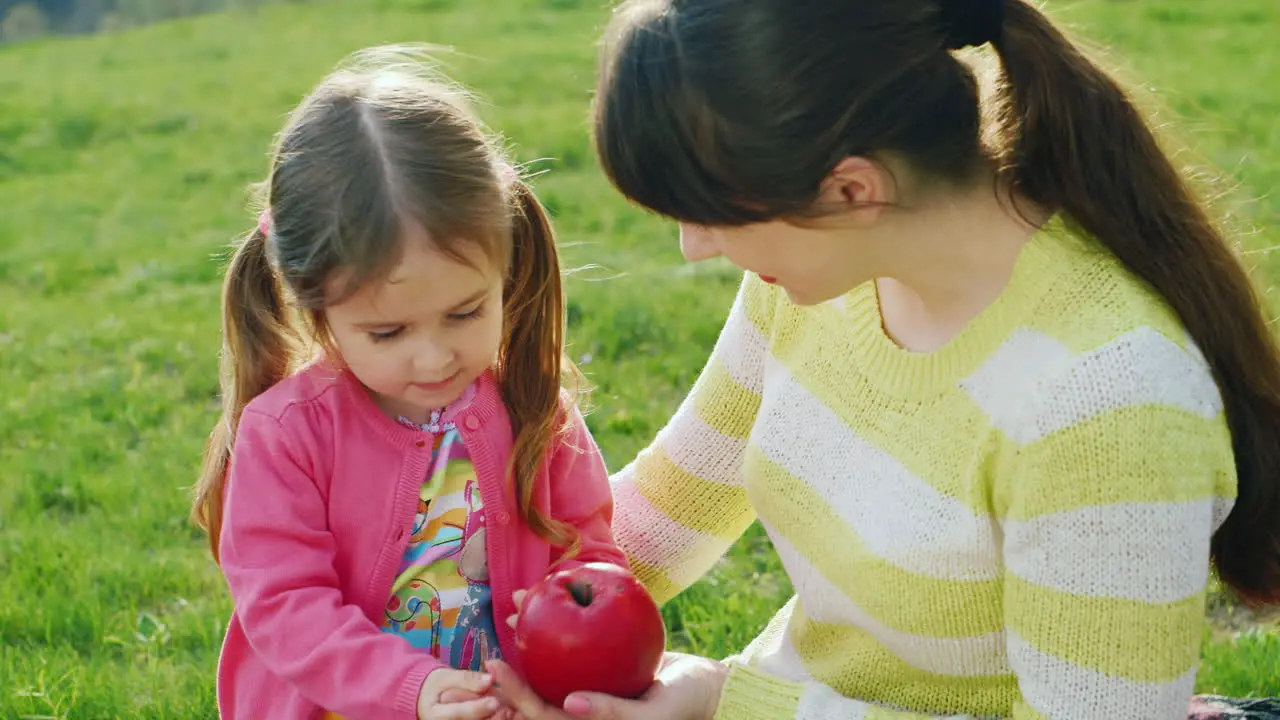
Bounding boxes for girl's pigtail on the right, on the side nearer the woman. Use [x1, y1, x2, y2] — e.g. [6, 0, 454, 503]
[498, 178, 577, 552]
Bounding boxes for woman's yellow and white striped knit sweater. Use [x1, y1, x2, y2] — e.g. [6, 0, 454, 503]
[614, 220, 1235, 720]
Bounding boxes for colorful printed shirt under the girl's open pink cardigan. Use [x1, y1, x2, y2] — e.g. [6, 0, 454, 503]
[381, 389, 499, 670]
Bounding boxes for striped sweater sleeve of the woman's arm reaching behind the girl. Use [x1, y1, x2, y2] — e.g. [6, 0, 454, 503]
[613, 274, 773, 603]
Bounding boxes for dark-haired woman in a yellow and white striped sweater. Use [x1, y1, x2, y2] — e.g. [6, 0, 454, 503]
[497, 0, 1280, 720]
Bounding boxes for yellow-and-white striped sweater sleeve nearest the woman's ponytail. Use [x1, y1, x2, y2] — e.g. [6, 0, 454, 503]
[995, 328, 1235, 717]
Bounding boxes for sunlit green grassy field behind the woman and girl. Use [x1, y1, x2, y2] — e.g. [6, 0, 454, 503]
[0, 0, 1280, 720]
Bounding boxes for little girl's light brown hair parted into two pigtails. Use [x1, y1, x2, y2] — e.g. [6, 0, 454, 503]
[192, 47, 575, 560]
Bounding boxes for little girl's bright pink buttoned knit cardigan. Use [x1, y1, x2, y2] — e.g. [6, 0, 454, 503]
[218, 364, 626, 720]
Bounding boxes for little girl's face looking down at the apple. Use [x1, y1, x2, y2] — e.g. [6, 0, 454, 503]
[325, 228, 503, 423]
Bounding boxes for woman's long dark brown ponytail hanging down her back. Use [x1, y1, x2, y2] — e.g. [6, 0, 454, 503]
[995, 0, 1280, 602]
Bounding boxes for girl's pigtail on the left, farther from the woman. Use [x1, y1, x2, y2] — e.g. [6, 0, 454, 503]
[192, 224, 298, 561]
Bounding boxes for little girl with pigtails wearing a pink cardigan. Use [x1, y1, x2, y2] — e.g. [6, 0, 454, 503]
[195, 51, 625, 720]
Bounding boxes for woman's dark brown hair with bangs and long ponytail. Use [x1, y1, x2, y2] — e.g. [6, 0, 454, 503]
[594, 0, 1280, 602]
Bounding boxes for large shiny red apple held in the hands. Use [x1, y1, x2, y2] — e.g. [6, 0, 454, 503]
[516, 562, 667, 707]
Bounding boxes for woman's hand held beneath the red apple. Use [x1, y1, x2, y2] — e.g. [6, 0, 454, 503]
[486, 650, 728, 720]
